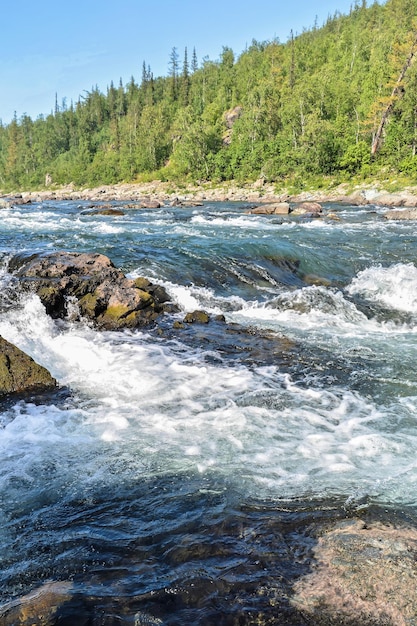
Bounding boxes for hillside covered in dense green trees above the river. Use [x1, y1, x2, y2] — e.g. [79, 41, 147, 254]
[0, 0, 417, 190]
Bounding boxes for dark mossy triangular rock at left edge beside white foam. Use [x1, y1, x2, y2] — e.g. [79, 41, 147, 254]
[0, 337, 57, 395]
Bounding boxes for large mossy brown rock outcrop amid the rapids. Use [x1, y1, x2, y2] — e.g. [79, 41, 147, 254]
[9, 252, 169, 330]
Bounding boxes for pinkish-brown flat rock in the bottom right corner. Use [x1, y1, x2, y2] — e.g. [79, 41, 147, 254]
[292, 520, 417, 626]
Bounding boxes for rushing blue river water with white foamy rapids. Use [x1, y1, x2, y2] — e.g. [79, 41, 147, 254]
[0, 202, 417, 625]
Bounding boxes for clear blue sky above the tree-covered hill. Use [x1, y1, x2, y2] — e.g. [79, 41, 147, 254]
[0, 0, 374, 123]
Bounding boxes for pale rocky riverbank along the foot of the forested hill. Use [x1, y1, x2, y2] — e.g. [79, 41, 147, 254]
[0, 180, 417, 208]
